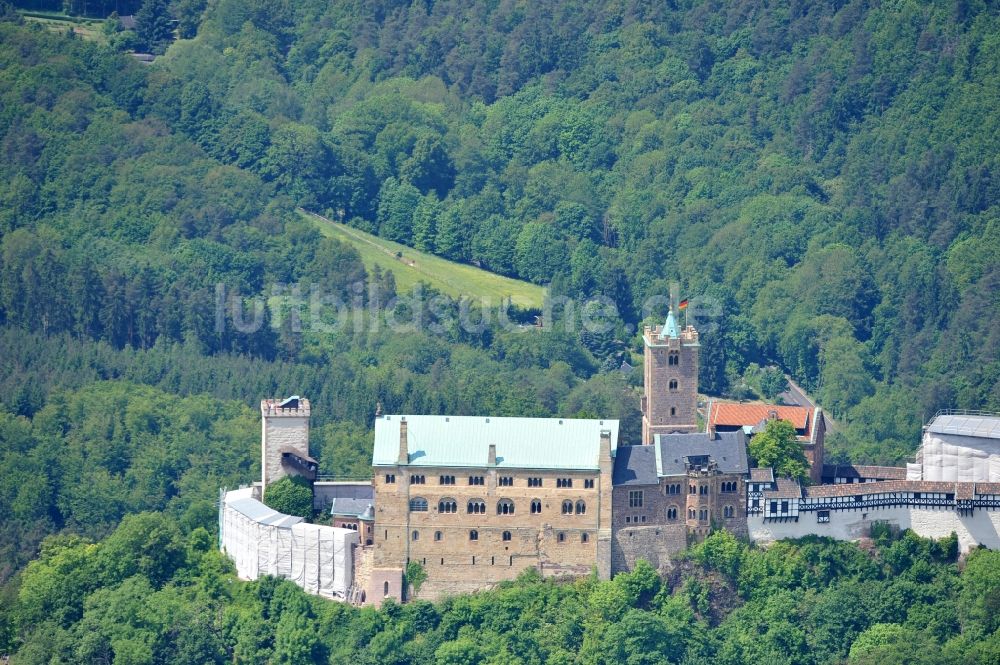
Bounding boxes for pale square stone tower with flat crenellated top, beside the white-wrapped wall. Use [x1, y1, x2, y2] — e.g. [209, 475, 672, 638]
[260, 395, 318, 491]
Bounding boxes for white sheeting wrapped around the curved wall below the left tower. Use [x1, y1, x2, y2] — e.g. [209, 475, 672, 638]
[219, 488, 358, 598]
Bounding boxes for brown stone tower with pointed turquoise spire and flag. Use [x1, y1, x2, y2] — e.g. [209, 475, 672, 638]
[641, 308, 698, 445]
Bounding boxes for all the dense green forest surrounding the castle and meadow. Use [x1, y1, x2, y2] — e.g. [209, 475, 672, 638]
[0, 0, 1000, 663]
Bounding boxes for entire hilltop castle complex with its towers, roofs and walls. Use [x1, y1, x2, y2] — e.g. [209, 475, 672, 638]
[219, 310, 1000, 605]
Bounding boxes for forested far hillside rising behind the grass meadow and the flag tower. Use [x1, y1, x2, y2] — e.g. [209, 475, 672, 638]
[150, 1, 1000, 456]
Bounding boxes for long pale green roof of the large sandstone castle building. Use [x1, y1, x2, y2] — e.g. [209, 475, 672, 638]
[372, 415, 618, 470]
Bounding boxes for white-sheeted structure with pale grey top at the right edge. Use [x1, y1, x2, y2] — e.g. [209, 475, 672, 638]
[918, 414, 1000, 483]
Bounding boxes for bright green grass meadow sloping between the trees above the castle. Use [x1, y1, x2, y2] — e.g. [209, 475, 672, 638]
[299, 210, 545, 308]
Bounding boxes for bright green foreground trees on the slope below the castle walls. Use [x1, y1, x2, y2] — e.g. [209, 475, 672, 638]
[8, 512, 1000, 665]
